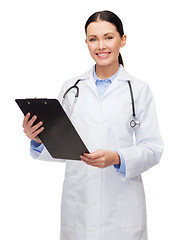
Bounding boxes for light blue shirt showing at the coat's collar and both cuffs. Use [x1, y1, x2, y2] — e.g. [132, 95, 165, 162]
[30, 65, 126, 174]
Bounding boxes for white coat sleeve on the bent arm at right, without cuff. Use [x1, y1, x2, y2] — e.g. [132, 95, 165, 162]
[119, 85, 163, 180]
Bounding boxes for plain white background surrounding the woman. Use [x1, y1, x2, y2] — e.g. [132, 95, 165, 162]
[0, 0, 185, 240]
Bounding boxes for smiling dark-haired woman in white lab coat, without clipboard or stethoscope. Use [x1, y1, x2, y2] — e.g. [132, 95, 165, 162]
[23, 11, 163, 240]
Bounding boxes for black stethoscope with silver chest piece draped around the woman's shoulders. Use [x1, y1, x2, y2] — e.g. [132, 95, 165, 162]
[62, 79, 141, 128]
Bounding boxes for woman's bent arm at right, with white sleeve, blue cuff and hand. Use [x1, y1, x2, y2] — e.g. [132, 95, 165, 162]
[81, 83, 163, 179]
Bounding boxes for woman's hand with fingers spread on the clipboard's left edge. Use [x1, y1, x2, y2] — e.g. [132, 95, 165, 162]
[22, 113, 44, 144]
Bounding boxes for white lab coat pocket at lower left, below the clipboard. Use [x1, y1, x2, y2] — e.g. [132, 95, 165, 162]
[61, 176, 77, 227]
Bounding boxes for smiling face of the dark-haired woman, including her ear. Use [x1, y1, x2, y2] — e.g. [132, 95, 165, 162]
[86, 21, 126, 66]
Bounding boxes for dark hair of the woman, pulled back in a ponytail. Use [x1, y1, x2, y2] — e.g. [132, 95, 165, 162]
[85, 11, 124, 66]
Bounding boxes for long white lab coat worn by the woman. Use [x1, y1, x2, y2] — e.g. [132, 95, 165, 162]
[34, 66, 163, 240]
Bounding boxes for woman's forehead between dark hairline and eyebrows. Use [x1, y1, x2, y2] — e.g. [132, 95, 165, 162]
[87, 21, 117, 36]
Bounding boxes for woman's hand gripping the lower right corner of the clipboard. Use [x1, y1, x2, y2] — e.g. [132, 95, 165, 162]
[80, 149, 120, 168]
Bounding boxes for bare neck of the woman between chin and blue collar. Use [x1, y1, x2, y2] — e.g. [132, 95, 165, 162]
[96, 62, 119, 79]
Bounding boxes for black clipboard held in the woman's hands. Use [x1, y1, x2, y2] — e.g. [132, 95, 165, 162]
[15, 98, 89, 160]
